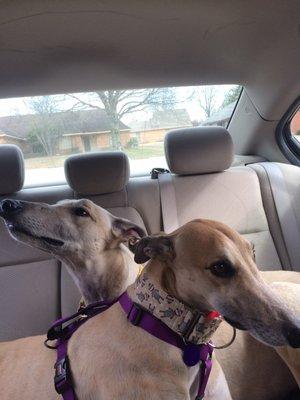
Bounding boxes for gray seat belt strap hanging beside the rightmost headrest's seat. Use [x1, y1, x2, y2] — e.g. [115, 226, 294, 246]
[157, 172, 179, 233]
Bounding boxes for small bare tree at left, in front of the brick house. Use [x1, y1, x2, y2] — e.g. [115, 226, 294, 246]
[25, 96, 61, 156]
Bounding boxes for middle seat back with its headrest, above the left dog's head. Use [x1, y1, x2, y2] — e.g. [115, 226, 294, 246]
[65, 152, 161, 232]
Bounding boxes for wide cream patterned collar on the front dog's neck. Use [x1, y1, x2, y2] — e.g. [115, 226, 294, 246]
[128, 267, 222, 344]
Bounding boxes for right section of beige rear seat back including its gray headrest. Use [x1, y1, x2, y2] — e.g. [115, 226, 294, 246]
[160, 127, 283, 270]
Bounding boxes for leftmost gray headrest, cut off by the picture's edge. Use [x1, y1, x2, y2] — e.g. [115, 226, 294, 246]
[0, 144, 24, 195]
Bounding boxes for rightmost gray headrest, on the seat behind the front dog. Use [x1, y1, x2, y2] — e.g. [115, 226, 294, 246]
[165, 126, 234, 175]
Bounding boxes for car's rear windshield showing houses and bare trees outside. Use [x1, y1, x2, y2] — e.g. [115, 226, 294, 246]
[0, 85, 241, 186]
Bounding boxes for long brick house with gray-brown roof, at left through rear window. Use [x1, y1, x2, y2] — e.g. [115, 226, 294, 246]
[0, 109, 130, 157]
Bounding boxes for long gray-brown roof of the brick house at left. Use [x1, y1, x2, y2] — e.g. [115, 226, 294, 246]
[0, 109, 130, 139]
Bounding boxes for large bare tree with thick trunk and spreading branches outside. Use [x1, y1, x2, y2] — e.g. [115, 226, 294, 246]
[68, 88, 176, 150]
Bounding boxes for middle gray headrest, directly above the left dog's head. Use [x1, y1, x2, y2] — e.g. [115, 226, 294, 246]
[65, 151, 130, 195]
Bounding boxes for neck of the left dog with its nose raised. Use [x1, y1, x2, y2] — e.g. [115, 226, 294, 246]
[64, 244, 140, 304]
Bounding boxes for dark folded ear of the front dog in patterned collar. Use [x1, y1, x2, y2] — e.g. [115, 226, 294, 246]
[134, 236, 175, 264]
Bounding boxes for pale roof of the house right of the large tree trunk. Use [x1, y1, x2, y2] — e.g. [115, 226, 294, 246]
[129, 108, 192, 132]
